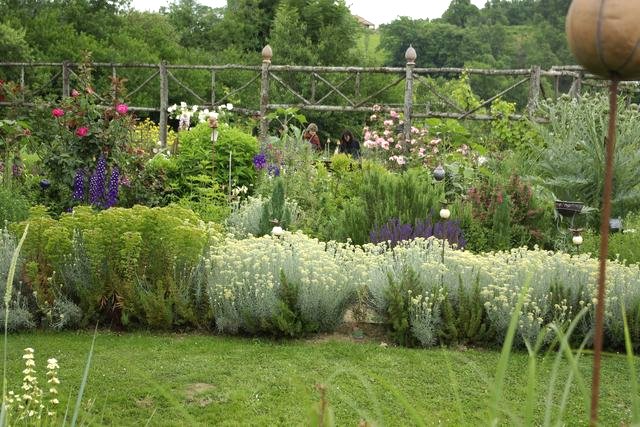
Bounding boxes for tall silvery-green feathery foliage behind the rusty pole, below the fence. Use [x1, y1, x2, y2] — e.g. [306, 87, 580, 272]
[537, 95, 640, 220]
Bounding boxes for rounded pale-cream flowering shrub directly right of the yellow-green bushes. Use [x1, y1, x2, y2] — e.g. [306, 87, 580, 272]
[206, 232, 368, 335]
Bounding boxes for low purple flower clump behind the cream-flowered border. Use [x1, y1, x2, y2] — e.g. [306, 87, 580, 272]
[369, 217, 467, 248]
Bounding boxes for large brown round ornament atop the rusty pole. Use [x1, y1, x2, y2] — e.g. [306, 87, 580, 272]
[566, 0, 640, 80]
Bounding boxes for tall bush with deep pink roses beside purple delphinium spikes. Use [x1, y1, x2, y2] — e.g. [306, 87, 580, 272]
[35, 69, 141, 209]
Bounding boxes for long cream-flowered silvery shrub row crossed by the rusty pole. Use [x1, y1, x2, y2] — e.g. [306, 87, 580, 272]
[364, 239, 640, 348]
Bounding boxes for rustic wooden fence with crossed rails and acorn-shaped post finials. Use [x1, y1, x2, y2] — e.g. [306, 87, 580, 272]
[0, 45, 640, 145]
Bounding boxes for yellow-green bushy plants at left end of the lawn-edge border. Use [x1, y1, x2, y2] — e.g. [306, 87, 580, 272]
[13, 206, 212, 329]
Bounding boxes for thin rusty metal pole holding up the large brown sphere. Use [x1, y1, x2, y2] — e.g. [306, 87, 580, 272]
[589, 78, 618, 427]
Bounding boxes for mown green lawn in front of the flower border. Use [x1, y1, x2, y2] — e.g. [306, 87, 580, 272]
[3, 332, 638, 426]
